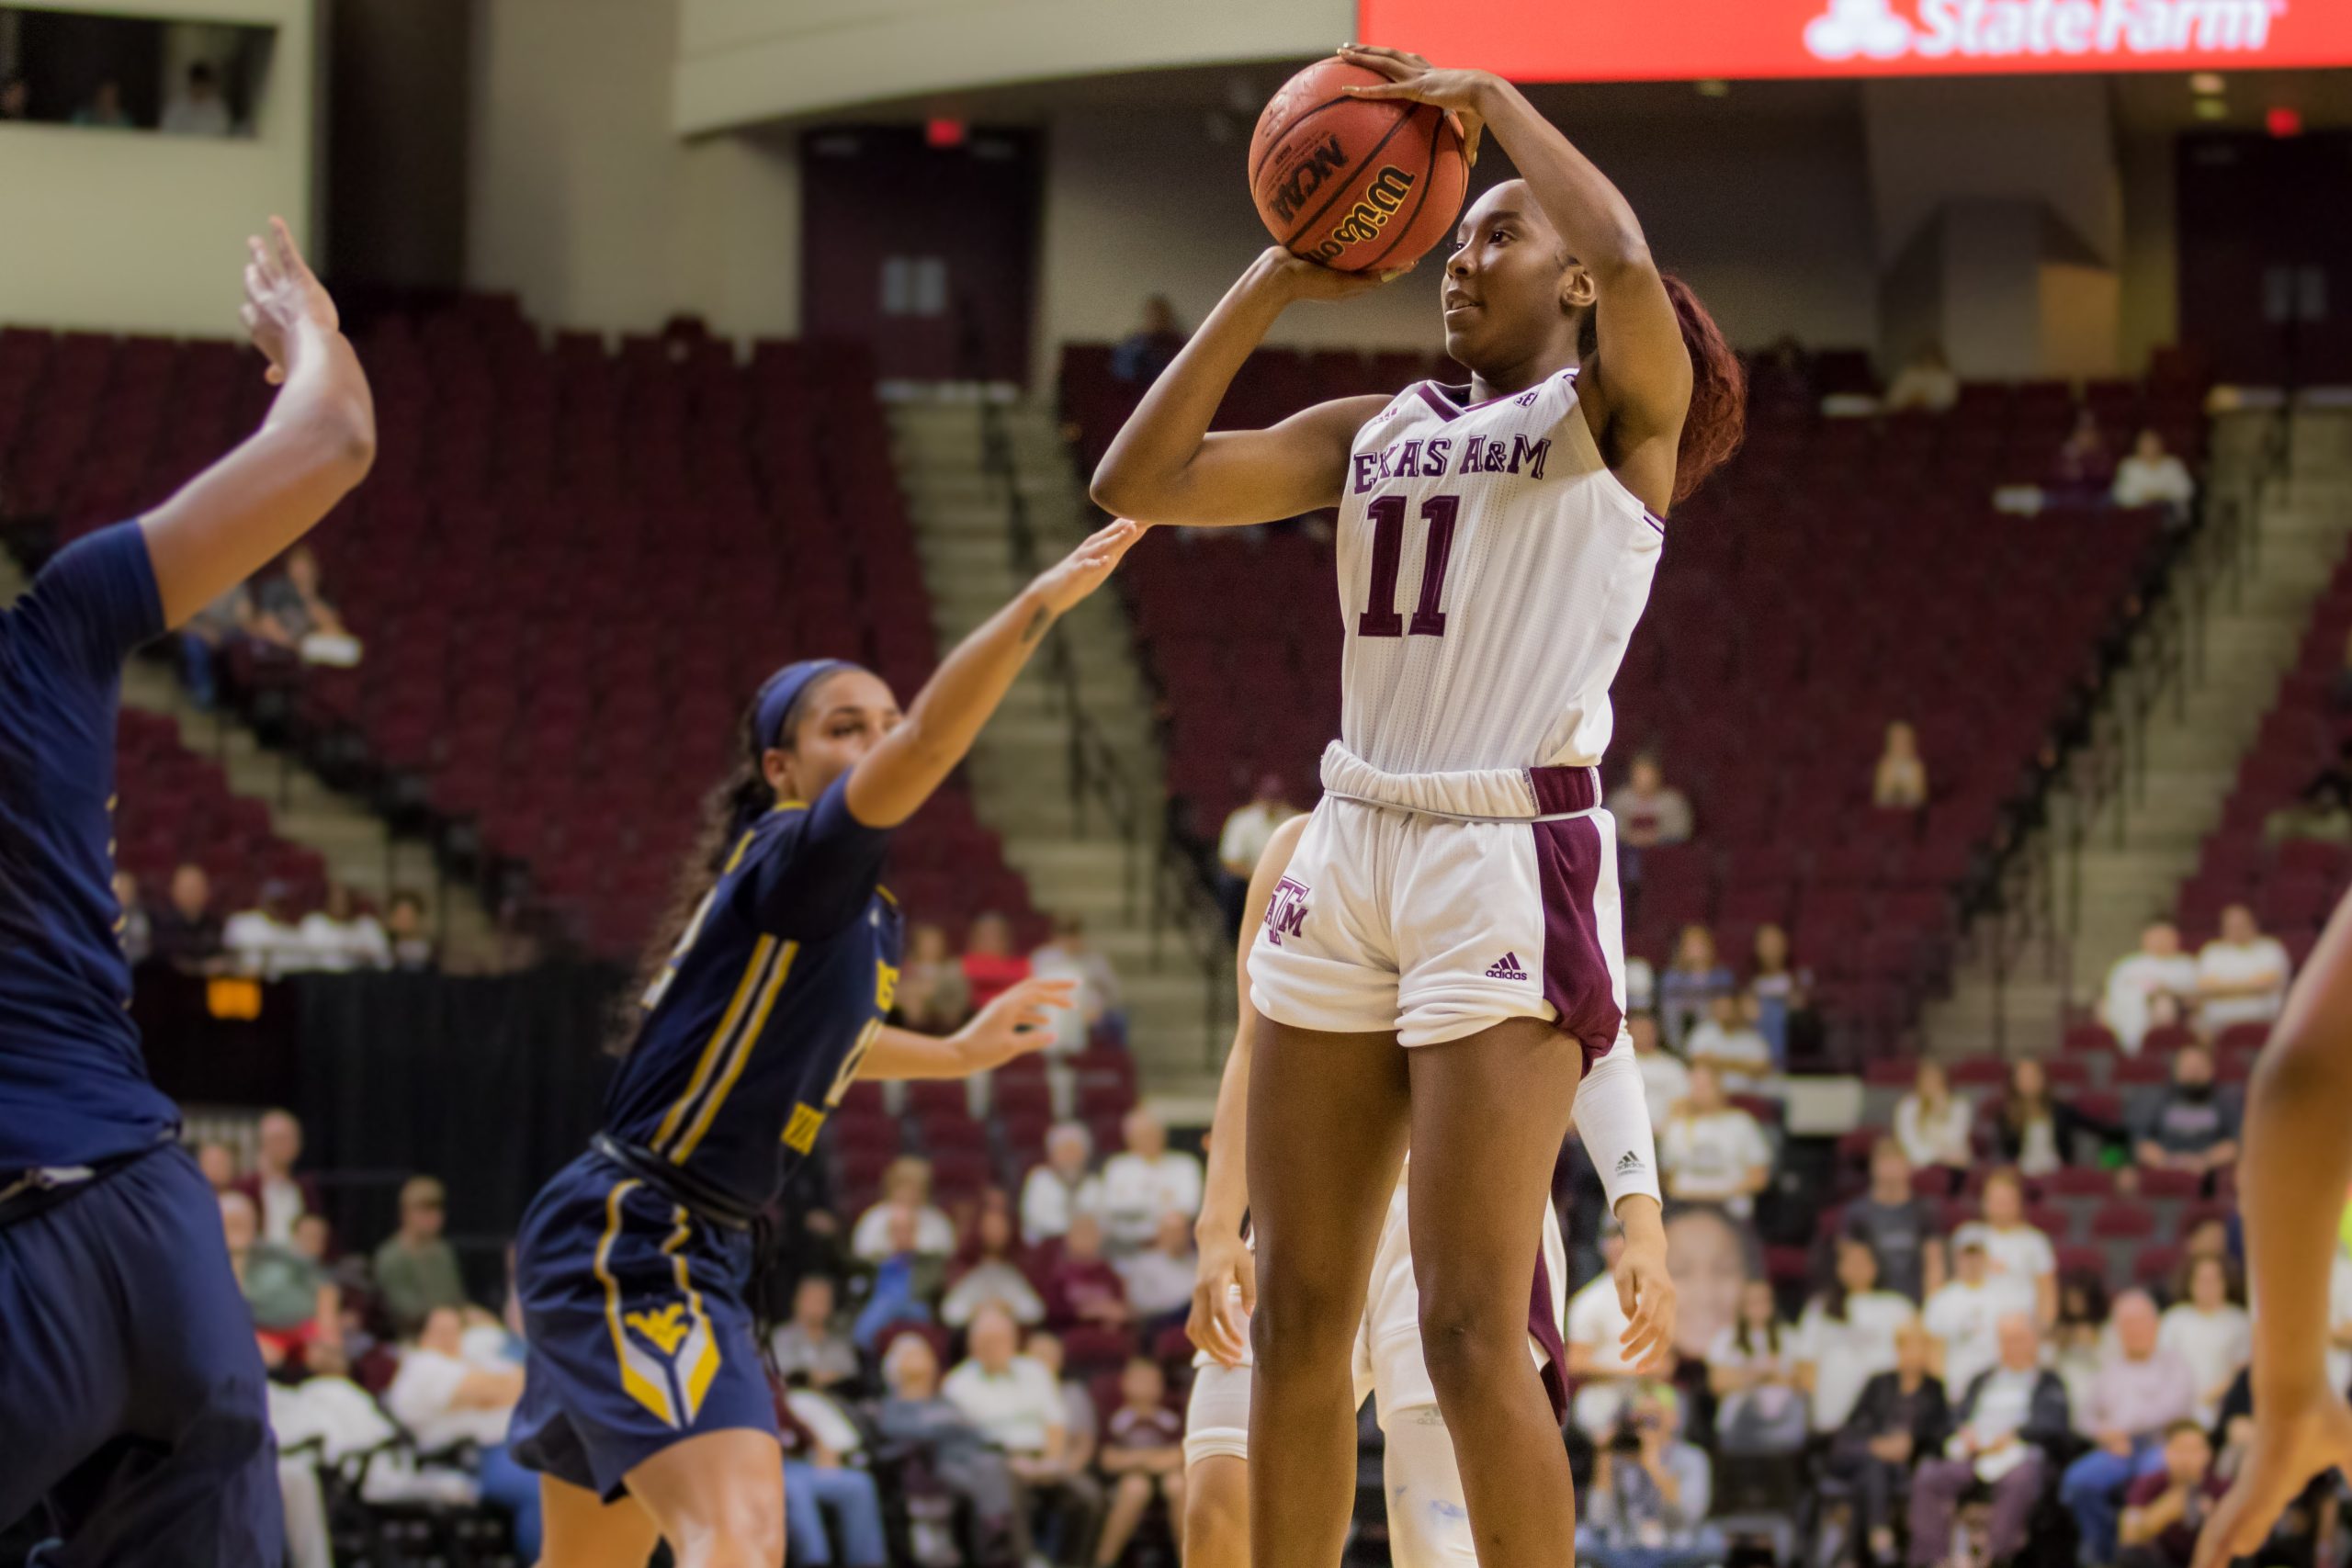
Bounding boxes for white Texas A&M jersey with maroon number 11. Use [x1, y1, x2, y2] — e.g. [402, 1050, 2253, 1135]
[1339, 369, 1665, 773]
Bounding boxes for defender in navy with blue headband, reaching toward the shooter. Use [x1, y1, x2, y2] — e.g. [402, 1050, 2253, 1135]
[513, 522, 1141, 1568]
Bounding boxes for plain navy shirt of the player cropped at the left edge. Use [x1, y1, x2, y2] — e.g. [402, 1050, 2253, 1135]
[0, 522, 179, 1170]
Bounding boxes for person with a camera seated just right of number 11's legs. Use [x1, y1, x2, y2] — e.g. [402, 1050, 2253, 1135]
[1576, 1382, 1729, 1568]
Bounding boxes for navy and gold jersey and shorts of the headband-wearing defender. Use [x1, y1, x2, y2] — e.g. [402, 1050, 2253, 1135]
[513, 778, 900, 1497]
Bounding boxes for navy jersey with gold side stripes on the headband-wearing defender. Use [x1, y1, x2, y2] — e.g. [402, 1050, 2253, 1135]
[605, 776, 903, 1208]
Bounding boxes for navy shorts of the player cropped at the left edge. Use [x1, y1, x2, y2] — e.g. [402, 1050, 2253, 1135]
[0, 1145, 285, 1568]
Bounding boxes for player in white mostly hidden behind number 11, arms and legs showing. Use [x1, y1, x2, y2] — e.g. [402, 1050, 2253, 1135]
[1183, 816, 1675, 1568]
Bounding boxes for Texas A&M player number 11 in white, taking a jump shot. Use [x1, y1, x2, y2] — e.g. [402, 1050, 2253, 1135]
[1093, 47, 1746, 1568]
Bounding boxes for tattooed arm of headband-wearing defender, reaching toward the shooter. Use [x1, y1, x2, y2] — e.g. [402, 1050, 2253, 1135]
[849, 520, 1143, 828]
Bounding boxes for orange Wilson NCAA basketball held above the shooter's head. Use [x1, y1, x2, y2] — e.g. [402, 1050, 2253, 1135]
[1249, 59, 1470, 273]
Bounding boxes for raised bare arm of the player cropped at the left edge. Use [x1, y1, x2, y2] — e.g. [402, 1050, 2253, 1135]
[141, 219, 377, 626]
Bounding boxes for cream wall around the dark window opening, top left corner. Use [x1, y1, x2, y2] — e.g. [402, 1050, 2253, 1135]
[0, 0, 318, 336]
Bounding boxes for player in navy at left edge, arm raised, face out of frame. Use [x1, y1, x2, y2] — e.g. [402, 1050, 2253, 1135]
[0, 219, 377, 1568]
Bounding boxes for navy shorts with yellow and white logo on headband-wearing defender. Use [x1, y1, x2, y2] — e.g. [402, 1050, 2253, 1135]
[508, 1152, 776, 1502]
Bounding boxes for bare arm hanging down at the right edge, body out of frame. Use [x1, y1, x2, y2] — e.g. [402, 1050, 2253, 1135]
[2197, 898, 2352, 1568]
